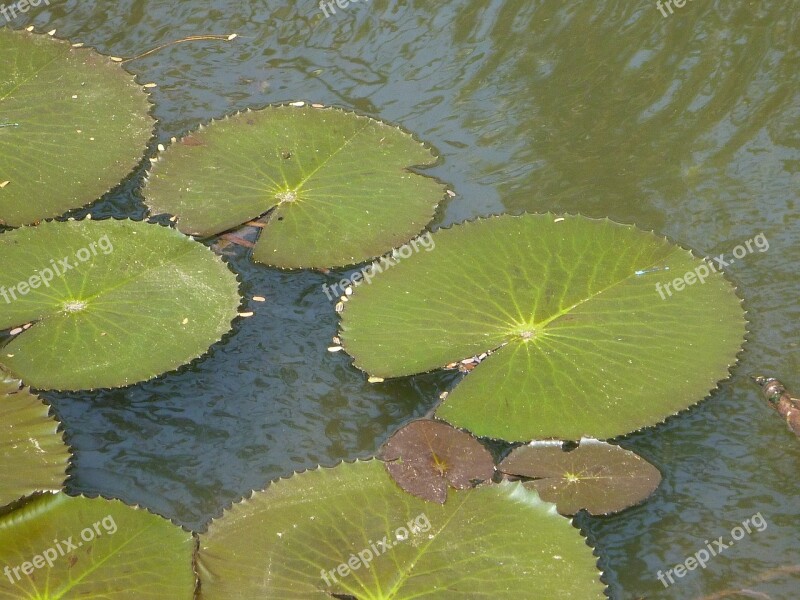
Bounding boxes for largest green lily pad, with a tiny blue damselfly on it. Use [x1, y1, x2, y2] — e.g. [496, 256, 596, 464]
[340, 214, 745, 441]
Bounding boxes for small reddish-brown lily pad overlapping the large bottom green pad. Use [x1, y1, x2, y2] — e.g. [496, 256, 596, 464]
[381, 419, 494, 504]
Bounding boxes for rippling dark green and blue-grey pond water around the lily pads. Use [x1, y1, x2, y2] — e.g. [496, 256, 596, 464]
[7, 0, 800, 600]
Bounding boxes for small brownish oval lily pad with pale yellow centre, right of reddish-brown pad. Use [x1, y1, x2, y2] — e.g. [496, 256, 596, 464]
[497, 439, 661, 515]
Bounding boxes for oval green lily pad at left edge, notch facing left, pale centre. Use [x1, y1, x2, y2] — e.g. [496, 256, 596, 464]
[0, 220, 240, 390]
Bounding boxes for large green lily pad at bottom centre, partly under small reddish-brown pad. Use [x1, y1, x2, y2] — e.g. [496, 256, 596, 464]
[197, 461, 604, 600]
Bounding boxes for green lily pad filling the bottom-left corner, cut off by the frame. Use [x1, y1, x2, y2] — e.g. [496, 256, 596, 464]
[0, 494, 196, 600]
